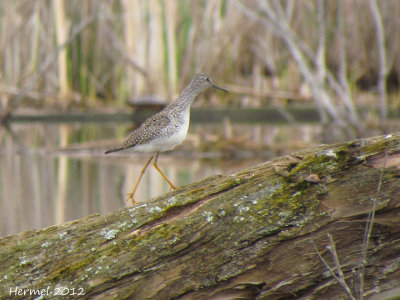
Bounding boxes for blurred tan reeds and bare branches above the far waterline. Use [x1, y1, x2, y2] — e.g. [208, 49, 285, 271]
[0, 0, 400, 135]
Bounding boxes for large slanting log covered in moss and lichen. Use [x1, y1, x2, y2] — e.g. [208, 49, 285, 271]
[0, 133, 400, 299]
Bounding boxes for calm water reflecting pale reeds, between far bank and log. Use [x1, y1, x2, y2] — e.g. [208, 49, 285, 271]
[0, 123, 319, 236]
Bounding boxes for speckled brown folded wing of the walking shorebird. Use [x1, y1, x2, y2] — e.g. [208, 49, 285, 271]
[106, 113, 171, 154]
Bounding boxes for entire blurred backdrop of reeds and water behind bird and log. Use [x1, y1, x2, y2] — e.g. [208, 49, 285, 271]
[0, 0, 400, 236]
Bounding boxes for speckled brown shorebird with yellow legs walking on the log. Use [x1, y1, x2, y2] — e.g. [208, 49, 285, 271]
[105, 73, 228, 205]
